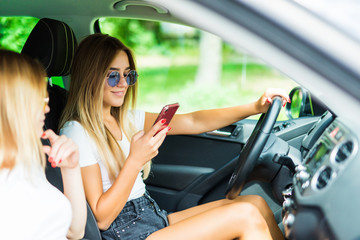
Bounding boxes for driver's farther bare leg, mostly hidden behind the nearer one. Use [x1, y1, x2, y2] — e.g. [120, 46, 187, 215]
[168, 195, 284, 240]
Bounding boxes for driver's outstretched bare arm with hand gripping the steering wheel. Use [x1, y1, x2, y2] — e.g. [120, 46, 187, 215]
[145, 89, 290, 134]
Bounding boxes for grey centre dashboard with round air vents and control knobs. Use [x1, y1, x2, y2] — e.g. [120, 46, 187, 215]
[283, 115, 360, 239]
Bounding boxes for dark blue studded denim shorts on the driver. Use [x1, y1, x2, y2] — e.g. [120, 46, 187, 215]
[101, 193, 169, 240]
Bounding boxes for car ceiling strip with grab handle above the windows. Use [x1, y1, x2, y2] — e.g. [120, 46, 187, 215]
[0, 0, 181, 23]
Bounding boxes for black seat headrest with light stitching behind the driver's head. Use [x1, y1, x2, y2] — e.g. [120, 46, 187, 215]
[21, 18, 77, 77]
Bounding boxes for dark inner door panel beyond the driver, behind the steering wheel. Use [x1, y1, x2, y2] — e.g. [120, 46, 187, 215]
[146, 118, 317, 212]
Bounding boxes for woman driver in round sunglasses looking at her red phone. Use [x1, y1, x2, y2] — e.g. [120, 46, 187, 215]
[60, 34, 288, 240]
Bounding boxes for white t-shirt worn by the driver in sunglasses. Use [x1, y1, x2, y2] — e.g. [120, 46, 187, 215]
[60, 110, 145, 201]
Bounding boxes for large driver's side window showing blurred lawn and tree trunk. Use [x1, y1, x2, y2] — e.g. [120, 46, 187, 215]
[99, 18, 297, 120]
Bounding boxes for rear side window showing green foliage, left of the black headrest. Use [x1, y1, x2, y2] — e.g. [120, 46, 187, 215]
[0, 17, 64, 88]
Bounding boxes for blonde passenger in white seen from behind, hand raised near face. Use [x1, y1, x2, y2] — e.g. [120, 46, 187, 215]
[0, 50, 86, 240]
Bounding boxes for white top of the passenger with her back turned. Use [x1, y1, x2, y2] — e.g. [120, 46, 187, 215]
[0, 166, 72, 240]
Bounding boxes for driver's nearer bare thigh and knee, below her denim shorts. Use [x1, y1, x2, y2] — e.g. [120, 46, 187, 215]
[147, 202, 272, 240]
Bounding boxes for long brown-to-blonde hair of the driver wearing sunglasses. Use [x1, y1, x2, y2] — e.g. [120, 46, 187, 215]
[60, 33, 150, 181]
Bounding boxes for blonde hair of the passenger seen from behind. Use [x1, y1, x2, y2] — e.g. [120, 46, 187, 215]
[0, 49, 47, 172]
